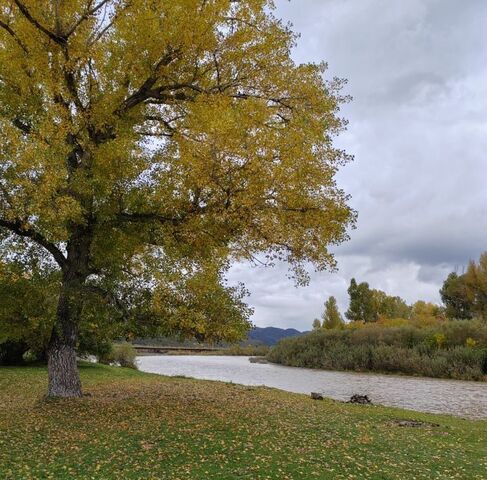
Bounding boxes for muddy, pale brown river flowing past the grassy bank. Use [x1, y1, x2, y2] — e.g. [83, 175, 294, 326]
[137, 355, 487, 418]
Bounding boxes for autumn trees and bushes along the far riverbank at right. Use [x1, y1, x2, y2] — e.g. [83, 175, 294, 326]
[268, 252, 487, 380]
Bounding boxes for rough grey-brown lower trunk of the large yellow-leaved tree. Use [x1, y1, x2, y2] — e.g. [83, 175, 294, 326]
[47, 282, 82, 398]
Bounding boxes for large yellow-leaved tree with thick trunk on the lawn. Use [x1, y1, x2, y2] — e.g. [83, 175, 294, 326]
[0, 0, 354, 396]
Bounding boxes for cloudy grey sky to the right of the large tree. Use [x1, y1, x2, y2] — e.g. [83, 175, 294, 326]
[229, 0, 487, 330]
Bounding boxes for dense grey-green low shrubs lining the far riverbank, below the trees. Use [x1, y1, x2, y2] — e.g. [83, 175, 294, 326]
[267, 320, 487, 380]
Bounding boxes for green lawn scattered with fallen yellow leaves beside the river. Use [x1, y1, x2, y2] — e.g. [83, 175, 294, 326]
[0, 365, 487, 480]
